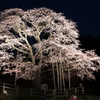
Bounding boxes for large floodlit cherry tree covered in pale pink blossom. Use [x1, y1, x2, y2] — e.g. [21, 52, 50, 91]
[0, 8, 100, 88]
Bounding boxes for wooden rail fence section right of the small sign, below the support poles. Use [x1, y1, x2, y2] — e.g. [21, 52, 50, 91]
[47, 87, 84, 100]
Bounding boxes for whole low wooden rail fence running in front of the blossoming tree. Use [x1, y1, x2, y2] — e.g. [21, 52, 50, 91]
[0, 83, 84, 100]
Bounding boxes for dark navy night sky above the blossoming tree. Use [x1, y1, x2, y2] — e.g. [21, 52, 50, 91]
[0, 0, 100, 36]
